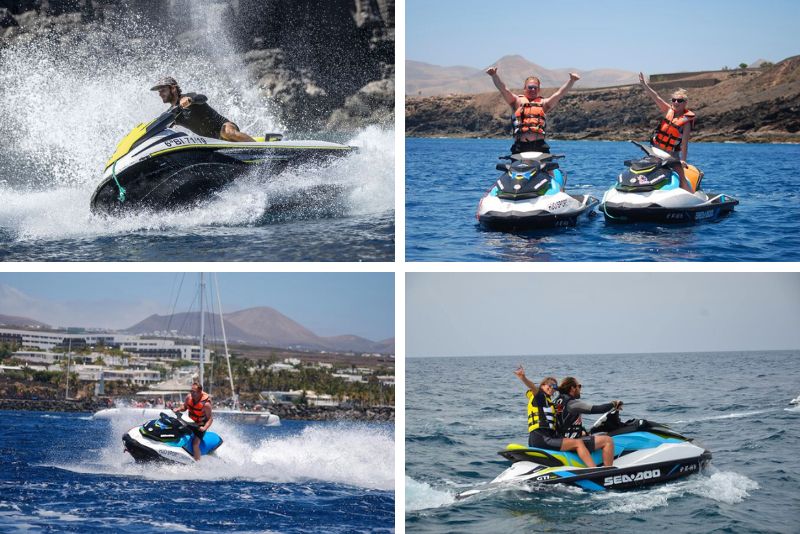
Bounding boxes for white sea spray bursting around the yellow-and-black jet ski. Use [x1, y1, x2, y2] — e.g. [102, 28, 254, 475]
[0, 9, 394, 242]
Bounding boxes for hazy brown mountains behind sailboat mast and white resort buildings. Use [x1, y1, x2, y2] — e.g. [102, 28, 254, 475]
[125, 307, 394, 354]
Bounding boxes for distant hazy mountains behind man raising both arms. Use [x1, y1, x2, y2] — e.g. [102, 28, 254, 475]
[406, 55, 637, 96]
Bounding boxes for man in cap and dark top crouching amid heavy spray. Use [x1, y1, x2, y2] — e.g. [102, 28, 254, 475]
[150, 76, 255, 142]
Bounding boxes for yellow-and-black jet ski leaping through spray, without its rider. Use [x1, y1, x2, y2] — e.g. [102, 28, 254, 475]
[91, 106, 355, 213]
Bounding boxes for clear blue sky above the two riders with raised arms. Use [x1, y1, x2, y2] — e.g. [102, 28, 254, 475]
[406, 0, 800, 74]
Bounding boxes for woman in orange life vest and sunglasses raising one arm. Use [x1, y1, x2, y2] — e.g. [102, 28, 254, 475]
[639, 72, 697, 193]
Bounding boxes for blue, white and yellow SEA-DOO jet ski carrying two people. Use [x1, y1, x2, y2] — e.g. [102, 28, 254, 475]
[456, 410, 711, 499]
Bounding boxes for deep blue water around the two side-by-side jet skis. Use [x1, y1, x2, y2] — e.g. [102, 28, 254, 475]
[406, 138, 800, 261]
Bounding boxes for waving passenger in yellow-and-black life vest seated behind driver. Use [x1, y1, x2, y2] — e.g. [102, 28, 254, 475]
[514, 366, 597, 467]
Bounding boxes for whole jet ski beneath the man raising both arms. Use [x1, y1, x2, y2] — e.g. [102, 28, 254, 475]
[476, 152, 597, 231]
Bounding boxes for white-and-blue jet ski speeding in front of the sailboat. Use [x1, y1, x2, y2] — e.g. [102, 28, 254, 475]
[122, 412, 222, 464]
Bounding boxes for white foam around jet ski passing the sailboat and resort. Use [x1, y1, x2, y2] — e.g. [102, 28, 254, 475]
[55, 416, 394, 491]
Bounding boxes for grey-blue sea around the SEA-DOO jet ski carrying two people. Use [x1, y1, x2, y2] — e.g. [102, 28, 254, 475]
[405, 351, 800, 533]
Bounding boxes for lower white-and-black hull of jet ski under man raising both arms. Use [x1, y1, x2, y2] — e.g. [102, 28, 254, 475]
[477, 193, 598, 232]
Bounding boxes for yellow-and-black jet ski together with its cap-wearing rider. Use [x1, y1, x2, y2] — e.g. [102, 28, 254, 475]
[90, 77, 355, 214]
